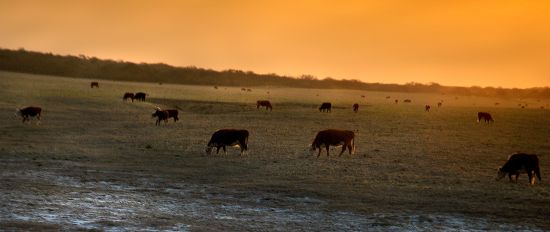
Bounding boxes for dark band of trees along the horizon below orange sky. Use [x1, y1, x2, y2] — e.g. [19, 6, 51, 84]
[0, 49, 550, 98]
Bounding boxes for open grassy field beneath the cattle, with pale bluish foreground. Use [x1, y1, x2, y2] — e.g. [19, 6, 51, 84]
[0, 72, 550, 231]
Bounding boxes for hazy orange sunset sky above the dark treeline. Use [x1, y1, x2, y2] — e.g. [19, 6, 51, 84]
[0, 0, 550, 88]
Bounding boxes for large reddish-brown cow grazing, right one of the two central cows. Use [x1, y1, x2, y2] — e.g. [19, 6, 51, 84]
[311, 129, 355, 157]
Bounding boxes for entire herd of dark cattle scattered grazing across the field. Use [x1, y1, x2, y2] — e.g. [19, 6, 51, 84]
[12, 82, 541, 184]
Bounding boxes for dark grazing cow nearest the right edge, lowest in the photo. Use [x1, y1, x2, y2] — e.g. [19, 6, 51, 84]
[496, 153, 541, 185]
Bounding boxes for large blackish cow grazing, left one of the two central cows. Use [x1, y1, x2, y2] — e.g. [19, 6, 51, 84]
[206, 129, 249, 155]
